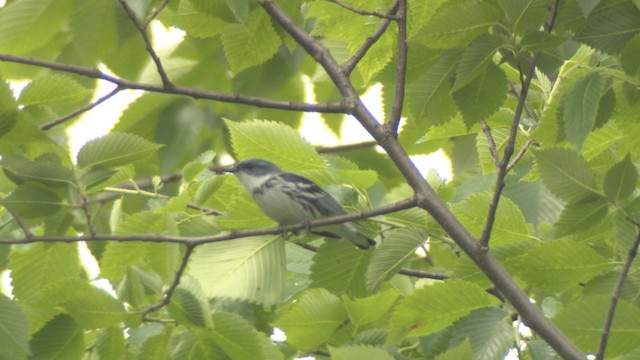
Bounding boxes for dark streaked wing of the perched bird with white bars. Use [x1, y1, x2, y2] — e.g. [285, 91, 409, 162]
[278, 172, 346, 217]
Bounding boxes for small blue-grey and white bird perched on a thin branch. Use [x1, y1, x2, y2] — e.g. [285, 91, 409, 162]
[224, 159, 376, 249]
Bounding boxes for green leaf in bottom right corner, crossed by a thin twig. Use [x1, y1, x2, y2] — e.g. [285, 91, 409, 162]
[553, 295, 640, 358]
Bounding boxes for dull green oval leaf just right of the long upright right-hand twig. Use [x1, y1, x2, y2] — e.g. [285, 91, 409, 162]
[535, 148, 598, 202]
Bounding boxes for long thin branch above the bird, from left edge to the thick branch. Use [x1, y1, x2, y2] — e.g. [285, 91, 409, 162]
[0, 54, 348, 114]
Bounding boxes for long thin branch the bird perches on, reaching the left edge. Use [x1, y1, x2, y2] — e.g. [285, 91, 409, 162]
[0, 196, 418, 246]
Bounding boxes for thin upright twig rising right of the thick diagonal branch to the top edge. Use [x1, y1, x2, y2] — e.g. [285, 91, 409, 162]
[480, 0, 560, 247]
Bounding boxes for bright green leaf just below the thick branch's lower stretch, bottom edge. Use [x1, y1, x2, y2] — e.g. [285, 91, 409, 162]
[387, 280, 498, 344]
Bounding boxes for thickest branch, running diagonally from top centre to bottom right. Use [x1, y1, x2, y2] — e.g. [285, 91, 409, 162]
[260, 0, 585, 360]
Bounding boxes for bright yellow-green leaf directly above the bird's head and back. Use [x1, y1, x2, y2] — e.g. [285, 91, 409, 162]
[226, 120, 322, 171]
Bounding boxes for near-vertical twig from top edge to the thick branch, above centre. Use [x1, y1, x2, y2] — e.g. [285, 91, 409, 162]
[386, 0, 409, 135]
